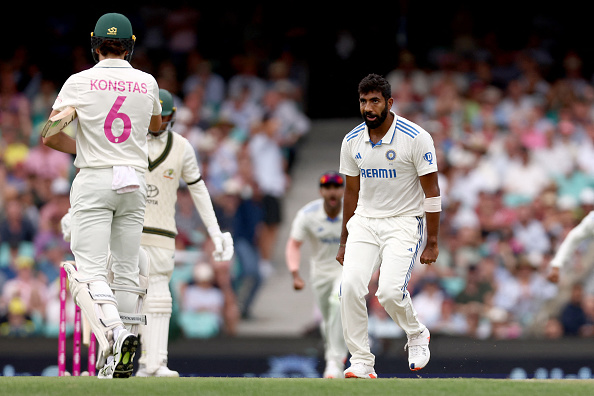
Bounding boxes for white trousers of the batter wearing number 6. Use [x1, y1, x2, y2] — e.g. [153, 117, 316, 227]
[70, 168, 146, 287]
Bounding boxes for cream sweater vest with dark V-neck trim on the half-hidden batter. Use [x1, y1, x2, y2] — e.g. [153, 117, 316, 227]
[141, 131, 202, 250]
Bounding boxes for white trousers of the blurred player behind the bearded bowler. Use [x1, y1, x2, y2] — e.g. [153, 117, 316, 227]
[312, 274, 347, 367]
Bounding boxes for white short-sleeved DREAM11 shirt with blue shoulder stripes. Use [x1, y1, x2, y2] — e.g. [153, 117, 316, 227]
[340, 112, 437, 218]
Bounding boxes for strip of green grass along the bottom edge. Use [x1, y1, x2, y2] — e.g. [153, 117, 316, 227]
[0, 377, 594, 396]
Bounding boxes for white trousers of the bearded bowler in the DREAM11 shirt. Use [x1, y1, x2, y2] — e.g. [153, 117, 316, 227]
[340, 214, 425, 366]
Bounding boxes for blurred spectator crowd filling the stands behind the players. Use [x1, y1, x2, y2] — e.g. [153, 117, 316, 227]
[0, 7, 594, 352]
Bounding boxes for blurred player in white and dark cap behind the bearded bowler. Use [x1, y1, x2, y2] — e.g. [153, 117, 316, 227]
[285, 172, 348, 378]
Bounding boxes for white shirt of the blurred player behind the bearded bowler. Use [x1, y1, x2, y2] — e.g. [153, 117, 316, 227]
[291, 198, 342, 279]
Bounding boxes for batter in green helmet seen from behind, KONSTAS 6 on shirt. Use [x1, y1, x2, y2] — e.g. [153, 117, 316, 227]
[43, 13, 161, 378]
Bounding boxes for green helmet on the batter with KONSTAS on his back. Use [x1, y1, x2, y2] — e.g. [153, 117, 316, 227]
[91, 12, 136, 62]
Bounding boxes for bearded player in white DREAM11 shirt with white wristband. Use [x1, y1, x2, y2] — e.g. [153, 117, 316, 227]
[336, 74, 441, 378]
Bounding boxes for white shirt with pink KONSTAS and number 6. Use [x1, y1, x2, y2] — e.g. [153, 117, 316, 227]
[53, 59, 161, 172]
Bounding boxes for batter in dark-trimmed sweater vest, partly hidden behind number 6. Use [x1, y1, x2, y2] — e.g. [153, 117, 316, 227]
[136, 89, 233, 377]
